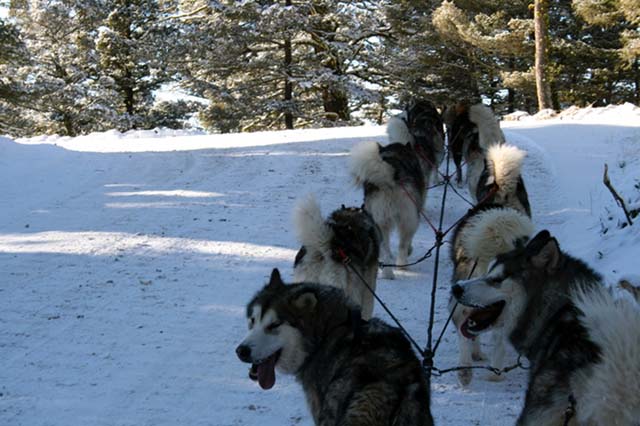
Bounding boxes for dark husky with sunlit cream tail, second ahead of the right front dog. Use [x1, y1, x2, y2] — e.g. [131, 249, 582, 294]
[478, 145, 531, 217]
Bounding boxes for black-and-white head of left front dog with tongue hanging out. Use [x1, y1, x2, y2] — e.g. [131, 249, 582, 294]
[236, 269, 359, 389]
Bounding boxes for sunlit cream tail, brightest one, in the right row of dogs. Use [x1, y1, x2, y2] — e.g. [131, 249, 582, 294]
[486, 145, 527, 194]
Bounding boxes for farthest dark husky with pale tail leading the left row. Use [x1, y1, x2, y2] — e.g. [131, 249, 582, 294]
[387, 100, 444, 185]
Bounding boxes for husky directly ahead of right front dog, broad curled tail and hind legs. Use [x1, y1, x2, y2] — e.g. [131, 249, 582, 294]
[449, 203, 534, 386]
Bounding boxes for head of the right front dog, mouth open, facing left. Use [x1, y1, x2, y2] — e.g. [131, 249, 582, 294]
[451, 231, 563, 337]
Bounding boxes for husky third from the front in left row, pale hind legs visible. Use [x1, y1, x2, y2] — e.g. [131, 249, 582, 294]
[351, 142, 426, 279]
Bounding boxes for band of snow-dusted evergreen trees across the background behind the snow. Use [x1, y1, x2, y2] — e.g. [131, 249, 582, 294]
[0, 0, 640, 136]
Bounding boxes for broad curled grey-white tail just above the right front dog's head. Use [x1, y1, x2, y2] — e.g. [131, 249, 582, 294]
[461, 208, 535, 266]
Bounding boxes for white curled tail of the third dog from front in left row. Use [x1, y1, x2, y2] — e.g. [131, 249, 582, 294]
[350, 141, 394, 186]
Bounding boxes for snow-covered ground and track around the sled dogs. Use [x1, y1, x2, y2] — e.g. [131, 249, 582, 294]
[0, 105, 640, 426]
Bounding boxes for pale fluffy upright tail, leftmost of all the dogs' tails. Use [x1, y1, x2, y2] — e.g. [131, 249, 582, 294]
[293, 195, 333, 253]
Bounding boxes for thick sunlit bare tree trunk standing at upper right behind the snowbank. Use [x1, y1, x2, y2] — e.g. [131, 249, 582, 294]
[533, 0, 553, 110]
